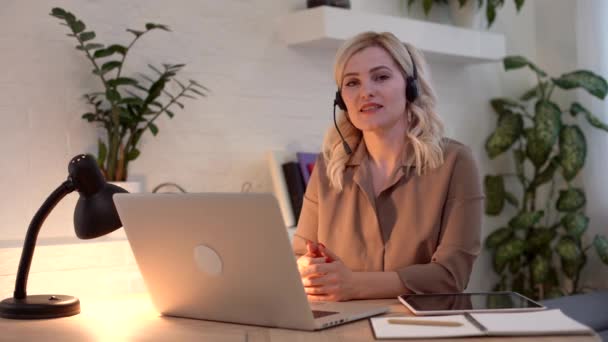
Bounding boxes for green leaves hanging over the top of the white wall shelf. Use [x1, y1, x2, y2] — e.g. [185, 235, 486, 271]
[407, 0, 525, 28]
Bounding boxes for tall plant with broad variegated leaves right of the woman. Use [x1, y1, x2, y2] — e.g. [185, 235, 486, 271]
[484, 56, 608, 299]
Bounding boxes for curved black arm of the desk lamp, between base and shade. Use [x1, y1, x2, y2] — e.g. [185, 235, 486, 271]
[13, 178, 75, 299]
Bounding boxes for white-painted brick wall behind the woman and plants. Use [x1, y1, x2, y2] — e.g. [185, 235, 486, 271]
[0, 0, 604, 295]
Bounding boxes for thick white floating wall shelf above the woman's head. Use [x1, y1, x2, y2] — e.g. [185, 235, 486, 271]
[279, 6, 505, 63]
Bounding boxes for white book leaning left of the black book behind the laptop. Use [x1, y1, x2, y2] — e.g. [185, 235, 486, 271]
[266, 150, 296, 228]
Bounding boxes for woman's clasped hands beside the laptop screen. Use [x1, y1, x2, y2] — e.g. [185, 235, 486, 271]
[301, 244, 357, 302]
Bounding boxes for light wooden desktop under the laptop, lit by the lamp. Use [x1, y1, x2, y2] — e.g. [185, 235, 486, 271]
[0, 294, 600, 342]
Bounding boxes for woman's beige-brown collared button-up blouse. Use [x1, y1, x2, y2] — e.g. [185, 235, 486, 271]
[293, 139, 484, 293]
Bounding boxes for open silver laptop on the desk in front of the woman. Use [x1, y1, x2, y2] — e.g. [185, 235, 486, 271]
[114, 193, 388, 330]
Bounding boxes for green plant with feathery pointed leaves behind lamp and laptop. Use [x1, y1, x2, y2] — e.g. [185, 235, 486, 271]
[51, 8, 208, 181]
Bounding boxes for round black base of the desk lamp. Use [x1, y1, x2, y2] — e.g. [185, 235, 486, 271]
[0, 295, 80, 319]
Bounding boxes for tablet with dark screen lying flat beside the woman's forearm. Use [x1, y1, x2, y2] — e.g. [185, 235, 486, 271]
[398, 291, 546, 316]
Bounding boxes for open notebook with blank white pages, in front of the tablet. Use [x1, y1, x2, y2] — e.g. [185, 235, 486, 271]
[370, 309, 593, 339]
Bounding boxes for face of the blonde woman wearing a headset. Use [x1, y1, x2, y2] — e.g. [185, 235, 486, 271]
[341, 46, 406, 132]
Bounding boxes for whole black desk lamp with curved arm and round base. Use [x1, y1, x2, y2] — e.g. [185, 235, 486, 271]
[0, 154, 127, 319]
